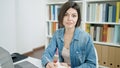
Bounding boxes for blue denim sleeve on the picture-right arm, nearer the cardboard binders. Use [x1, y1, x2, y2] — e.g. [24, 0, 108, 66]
[75, 36, 97, 68]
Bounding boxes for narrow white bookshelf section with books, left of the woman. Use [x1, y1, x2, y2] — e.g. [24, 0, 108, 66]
[45, 0, 67, 48]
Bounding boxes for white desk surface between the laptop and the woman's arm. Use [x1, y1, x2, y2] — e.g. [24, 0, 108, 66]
[14, 57, 45, 68]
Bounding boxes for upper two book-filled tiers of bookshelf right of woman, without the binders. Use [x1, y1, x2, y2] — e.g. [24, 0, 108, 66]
[85, 0, 120, 46]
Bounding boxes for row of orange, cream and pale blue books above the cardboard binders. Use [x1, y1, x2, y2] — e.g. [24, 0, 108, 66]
[86, 24, 120, 44]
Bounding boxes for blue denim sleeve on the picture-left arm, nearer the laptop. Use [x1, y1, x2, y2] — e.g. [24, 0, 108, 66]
[41, 32, 57, 66]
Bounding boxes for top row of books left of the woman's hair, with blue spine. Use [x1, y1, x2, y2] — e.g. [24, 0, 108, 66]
[49, 4, 61, 21]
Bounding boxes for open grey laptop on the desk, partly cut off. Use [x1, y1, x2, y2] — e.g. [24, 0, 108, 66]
[0, 47, 38, 68]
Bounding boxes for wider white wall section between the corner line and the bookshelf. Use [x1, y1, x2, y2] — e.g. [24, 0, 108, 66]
[16, 0, 46, 53]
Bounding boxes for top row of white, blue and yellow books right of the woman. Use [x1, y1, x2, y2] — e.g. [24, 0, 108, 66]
[87, 2, 120, 23]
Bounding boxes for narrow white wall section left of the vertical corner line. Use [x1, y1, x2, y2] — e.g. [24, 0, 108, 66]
[0, 0, 16, 53]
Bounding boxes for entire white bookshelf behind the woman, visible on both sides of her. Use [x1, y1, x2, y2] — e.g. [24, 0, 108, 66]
[45, 0, 120, 68]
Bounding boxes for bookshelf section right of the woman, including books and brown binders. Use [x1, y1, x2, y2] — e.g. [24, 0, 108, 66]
[84, 0, 120, 68]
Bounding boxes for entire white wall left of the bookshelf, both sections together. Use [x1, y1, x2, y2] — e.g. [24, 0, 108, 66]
[0, 0, 47, 53]
